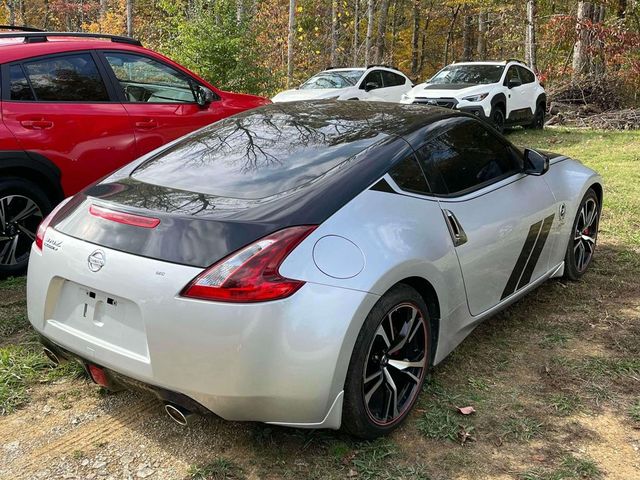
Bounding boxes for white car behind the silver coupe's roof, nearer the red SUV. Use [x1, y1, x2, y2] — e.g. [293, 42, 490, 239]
[271, 65, 413, 102]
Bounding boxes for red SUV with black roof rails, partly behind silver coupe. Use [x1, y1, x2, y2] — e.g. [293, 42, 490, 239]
[0, 30, 269, 277]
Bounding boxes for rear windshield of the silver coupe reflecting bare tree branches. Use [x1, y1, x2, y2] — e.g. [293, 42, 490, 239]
[132, 103, 386, 199]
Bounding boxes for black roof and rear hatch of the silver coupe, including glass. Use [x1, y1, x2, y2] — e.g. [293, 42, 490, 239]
[58, 101, 464, 267]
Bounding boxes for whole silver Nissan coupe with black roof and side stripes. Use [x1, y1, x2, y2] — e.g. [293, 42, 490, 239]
[28, 102, 602, 438]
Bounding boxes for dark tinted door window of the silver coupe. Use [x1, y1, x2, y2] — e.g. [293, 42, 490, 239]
[419, 120, 522, 195]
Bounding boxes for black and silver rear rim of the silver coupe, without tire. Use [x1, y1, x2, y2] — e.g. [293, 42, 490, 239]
[362, 303, 427, 425]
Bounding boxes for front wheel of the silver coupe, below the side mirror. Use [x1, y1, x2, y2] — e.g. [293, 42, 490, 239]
[564, 188, 601, 280]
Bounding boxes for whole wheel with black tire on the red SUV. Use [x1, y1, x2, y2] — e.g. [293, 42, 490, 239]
[0, 177, 52, 278]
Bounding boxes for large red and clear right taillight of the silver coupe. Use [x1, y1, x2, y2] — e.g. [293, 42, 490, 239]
[181, 225, 316, 303]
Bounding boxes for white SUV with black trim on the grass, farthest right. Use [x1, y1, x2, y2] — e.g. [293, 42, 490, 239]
[401, 60, 547, 132]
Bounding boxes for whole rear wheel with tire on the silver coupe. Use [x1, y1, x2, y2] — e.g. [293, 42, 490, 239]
[342, 284, 431, 439]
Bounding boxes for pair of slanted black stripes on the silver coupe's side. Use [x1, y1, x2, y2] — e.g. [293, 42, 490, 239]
[500, 214, 555, 300]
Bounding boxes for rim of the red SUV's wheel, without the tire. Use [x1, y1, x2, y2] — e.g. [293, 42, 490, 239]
[0, 195, 42, 266]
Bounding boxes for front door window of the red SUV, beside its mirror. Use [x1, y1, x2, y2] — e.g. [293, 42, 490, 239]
[104, 52, 196, 103]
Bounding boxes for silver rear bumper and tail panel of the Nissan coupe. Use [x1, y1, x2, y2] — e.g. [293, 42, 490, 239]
[27, 229, 379, 428]
